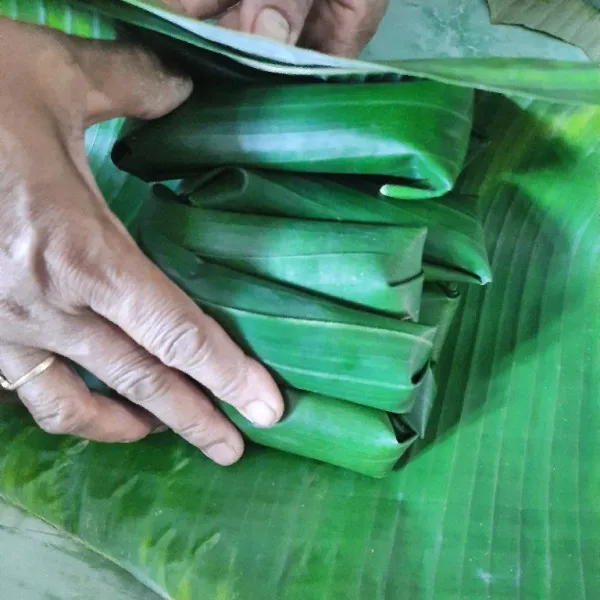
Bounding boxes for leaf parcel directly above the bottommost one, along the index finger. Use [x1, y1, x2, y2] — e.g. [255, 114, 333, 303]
[140, 227, 436, 412]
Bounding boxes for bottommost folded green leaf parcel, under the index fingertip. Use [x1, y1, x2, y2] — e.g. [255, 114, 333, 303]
[221, 390, 416, 477]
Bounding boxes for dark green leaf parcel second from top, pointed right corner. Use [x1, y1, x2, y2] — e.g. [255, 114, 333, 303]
[178, 167, 492, 285]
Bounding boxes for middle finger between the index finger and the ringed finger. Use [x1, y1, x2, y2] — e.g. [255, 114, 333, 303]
[54, 315, 244, 465]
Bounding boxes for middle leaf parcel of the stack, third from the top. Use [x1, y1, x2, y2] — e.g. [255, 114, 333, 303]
[150, 187, 426, 321]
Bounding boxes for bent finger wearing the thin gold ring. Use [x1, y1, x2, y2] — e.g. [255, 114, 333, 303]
[0, 345, 157, 442]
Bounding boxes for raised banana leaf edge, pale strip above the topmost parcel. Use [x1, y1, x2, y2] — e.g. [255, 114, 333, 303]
[86, 0, 600, 104]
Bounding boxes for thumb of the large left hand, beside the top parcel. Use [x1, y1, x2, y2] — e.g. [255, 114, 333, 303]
[71, 38, 193, 124]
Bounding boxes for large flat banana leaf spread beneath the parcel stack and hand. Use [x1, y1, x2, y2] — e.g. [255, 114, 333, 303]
[0, 0, 600, 600]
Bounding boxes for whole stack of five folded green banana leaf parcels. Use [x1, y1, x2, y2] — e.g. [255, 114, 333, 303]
[114, 81, 490, 477]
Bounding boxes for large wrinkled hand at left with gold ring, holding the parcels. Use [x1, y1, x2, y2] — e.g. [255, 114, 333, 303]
[0, 19, 283, 464]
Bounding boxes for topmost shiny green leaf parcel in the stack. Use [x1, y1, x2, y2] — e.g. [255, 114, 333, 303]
[113, 81, 473, 199]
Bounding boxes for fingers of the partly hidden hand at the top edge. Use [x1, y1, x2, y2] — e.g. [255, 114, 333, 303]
[162, 0, 389, 57]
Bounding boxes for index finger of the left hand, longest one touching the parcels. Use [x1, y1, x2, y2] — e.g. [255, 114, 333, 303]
[90, 247, 283, 427]
